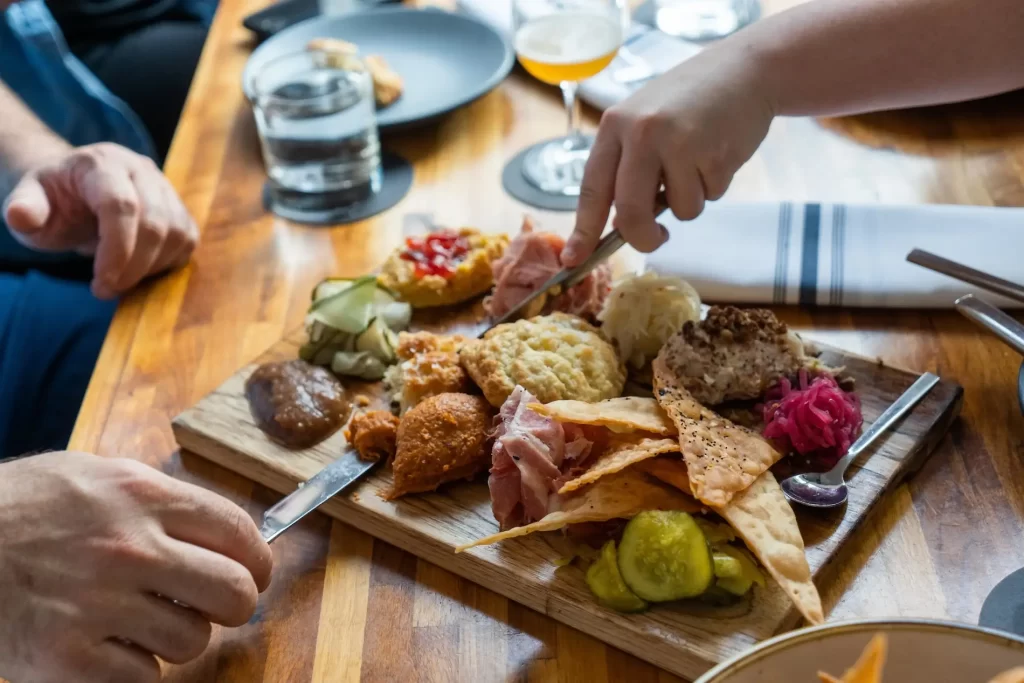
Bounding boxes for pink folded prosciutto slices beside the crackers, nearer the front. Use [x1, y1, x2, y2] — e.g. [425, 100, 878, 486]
[487, 386, 593, 529]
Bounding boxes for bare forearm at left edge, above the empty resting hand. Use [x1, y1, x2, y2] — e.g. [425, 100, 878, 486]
[0, 81, 71, 203]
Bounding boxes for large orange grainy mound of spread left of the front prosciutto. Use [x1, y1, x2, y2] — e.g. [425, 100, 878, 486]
[387, 393, 494, 500]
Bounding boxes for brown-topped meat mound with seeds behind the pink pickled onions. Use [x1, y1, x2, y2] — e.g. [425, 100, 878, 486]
[658, 306, 823, 405]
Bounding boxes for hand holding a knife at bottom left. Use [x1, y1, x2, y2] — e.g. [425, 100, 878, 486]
[0, 453, 273, 683]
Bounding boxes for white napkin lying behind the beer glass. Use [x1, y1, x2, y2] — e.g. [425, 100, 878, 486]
[458, 0, 700, 111]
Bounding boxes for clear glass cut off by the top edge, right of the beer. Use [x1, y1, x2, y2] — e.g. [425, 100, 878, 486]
[654, 0, 760, 40]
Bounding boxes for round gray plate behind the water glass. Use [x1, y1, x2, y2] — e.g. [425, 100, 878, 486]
[242, 7, 515, 130]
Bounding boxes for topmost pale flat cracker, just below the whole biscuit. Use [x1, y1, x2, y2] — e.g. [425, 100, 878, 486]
[527, 396, 676, 436]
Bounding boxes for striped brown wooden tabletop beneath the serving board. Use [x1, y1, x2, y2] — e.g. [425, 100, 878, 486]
[72, 0, 1024, 683]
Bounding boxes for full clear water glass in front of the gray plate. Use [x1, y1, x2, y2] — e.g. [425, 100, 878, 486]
[252, 51, 381, 203]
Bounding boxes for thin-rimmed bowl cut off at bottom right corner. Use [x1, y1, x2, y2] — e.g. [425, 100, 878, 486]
[696, 620, 1024, 683]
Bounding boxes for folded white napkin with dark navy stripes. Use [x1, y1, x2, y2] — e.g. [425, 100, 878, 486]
[645, 202, 1024, 308]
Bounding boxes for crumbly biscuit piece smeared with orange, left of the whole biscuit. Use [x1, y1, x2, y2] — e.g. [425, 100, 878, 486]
[384, 332, 473, 415]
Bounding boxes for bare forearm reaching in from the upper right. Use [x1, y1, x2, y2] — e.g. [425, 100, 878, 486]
[733, 0, 1024, 116]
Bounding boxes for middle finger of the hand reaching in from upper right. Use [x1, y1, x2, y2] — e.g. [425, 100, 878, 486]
[614, 145, 666, 253]
